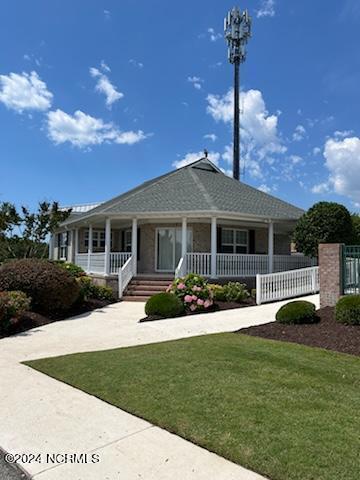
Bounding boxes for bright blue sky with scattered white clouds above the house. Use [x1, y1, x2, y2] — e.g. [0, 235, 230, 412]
[0, 0, 360, 211]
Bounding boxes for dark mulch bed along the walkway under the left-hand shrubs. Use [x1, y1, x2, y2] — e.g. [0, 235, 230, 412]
[0, 300, 113, 338]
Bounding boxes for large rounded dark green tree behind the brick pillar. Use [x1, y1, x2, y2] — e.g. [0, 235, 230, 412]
[293, 202, 353, 257]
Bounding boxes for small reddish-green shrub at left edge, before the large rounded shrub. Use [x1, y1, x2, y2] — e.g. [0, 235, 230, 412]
[0, 291, 31, 334]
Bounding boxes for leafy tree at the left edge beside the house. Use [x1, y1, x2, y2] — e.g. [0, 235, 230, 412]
[0, 202, 71, 261]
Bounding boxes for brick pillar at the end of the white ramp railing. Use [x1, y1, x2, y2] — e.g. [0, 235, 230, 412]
[319, 243, 342, 308]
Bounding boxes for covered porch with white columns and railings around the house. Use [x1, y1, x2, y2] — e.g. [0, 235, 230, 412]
[50, 216, 315, 278]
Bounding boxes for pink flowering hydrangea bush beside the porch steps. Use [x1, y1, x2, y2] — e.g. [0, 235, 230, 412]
[167, 273, 214, 312]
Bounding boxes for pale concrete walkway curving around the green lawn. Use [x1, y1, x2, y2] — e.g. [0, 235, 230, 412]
[0, 296, 318, 480]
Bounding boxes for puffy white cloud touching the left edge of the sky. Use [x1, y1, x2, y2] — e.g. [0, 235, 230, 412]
[0, 71, 53, 113]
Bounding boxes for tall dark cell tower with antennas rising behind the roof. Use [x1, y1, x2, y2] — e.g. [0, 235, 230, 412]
[224, 7, 251, 180]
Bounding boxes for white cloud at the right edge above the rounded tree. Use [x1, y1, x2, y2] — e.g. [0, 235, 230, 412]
[324, 137, 360, 202]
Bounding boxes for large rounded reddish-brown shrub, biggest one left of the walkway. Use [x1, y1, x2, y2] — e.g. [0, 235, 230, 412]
[0, 258, 80, 314]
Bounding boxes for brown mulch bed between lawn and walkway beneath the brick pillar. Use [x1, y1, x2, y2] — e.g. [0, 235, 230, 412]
[236, 307, 360, 356]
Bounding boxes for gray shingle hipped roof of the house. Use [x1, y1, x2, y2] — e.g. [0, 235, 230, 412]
[62, 158, 303, 224]
